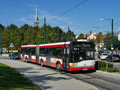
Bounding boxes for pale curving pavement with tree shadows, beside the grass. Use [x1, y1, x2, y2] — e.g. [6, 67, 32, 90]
[0, 59, 99, 90]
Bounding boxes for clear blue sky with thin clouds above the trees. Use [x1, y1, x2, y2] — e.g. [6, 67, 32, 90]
[0, 0, 120, 35]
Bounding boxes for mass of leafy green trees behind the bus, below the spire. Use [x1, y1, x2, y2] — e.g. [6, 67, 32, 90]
[2, 24, 75, 49]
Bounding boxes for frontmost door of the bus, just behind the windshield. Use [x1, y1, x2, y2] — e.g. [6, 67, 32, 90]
[63, 47, 70, 71]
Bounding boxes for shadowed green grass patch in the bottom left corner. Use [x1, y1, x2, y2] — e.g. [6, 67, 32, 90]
[0, 63, 35, 90]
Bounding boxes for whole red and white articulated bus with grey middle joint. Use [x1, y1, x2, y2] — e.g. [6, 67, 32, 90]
[21, 40, 95, 71]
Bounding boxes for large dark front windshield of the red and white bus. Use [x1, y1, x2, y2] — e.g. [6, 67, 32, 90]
[71, 43, 95, 62]
